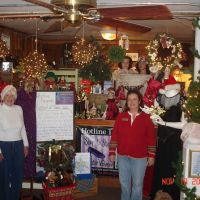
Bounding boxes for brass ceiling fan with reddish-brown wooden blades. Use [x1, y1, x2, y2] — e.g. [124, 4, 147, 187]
[0, 0, 172, 33]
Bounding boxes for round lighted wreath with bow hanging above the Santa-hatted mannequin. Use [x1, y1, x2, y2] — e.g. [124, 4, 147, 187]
[146, 33, 183, 70]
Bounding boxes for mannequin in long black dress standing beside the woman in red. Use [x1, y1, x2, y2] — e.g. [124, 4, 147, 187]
[152, 84, 183, 199]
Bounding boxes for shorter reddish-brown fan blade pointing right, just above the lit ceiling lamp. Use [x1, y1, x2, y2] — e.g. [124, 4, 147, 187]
[93, 18, 151, 33]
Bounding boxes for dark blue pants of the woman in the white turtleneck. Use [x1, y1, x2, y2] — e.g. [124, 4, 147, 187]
[0, 141, 24, 200]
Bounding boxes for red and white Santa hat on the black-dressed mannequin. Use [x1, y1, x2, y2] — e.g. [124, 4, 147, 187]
[159, 75, 181, 97]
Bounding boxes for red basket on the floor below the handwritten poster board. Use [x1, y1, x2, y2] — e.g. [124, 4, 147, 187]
[43, 183, 75, 200]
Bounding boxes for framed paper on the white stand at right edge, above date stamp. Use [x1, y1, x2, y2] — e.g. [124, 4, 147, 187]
[189, 150, 200, 178]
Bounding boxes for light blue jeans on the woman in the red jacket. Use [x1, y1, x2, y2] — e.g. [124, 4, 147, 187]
[118, 155, 147, 200]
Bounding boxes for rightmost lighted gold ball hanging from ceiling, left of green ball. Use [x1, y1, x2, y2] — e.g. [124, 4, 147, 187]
[72, 38, 98, 66]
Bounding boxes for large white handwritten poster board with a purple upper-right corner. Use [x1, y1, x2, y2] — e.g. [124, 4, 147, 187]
[36, 91, 74, 142]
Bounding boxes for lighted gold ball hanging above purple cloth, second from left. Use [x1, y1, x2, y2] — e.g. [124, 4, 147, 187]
[18, 51, 48, 79]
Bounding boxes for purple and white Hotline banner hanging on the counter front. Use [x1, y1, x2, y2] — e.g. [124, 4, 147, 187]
[76, 126, 118, 176]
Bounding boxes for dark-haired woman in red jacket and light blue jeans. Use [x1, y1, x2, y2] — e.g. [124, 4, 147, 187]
[109, 90, 156, 200]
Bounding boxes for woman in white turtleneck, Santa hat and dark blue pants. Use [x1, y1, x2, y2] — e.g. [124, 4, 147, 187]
[0, 85, 28, 200]
